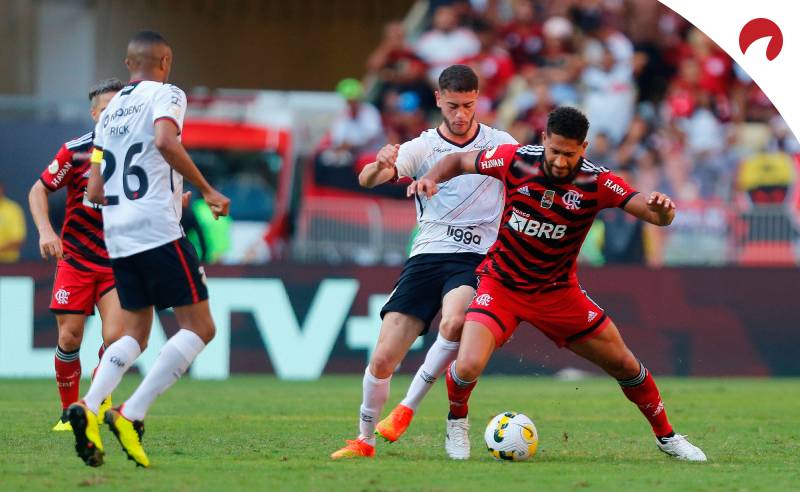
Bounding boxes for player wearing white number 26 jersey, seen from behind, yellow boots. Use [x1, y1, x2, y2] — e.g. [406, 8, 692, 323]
[67, 31, 230, 467]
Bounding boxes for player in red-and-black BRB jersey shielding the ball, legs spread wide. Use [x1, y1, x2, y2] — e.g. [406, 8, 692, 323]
[409, 107, 706, 461]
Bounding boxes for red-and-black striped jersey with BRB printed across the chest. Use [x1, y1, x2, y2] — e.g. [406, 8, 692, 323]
[475, 145, 637, 292]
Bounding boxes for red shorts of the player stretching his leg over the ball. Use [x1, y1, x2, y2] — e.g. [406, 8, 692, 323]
[467, 277, 611, 348]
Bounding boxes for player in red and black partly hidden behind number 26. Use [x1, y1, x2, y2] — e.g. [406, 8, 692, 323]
[28, 79, 123, 431]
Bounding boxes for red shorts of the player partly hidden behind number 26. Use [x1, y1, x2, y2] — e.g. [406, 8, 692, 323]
[50, 261, 114, 315]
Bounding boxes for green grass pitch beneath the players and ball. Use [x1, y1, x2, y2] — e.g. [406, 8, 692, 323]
[0, 376, 800, 492]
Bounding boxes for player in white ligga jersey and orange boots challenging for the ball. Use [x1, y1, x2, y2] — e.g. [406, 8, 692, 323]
[331, 65, 515, 459]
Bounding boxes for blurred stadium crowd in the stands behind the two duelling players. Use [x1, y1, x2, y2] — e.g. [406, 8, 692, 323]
[317, 0, 800, 264]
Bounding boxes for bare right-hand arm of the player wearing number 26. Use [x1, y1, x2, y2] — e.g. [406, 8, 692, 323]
[154, 119, 231, 218]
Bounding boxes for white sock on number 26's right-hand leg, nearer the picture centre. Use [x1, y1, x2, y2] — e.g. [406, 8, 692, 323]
[122, 330, 206, 420]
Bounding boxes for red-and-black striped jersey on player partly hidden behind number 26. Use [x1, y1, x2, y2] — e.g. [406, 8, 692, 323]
[39, 132, 111, 272]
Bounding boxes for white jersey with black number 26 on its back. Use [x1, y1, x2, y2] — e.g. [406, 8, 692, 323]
[94, 81, 186, 258]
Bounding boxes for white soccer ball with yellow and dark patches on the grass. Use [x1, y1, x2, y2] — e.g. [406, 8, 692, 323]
[483, 412, 539, 461]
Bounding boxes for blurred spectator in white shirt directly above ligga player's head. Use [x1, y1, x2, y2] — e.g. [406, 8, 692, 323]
[415, 5, 481, 83]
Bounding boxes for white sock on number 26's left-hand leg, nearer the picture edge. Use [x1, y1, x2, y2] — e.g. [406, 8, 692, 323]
[83, 335, 142, 413]
